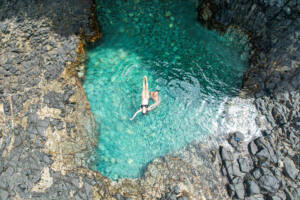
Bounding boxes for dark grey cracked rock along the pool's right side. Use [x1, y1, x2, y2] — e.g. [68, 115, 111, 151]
[198, 0, 300, 199]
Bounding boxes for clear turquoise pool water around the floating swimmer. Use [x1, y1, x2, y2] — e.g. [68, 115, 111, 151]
[83, 0, 248, 180]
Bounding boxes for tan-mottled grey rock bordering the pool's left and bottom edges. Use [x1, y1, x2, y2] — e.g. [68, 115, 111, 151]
[0, 0, 227, 200]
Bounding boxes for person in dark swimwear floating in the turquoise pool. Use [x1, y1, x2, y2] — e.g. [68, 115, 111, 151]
[130, 76, 160, 120]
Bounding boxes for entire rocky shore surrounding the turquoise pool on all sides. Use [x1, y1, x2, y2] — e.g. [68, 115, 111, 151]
[0, 0, 300, 200]
